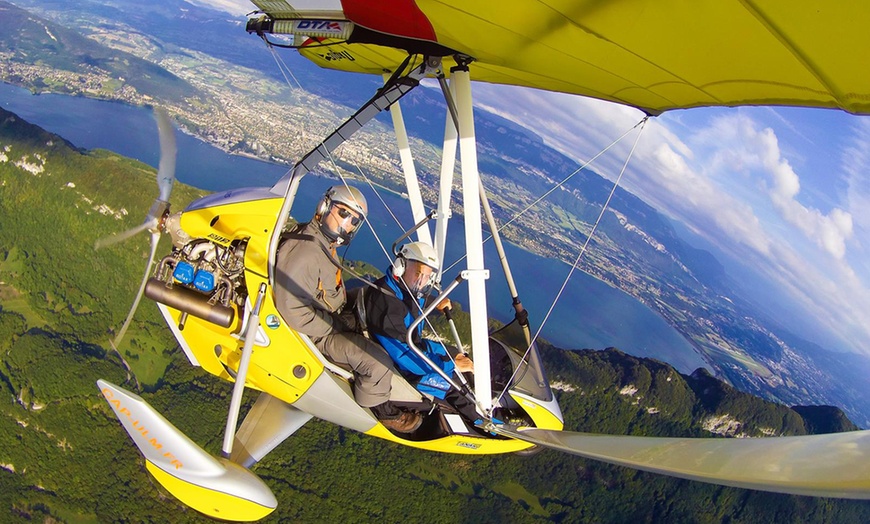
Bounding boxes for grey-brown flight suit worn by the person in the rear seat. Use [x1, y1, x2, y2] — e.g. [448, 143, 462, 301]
[275, 221, 393, 408]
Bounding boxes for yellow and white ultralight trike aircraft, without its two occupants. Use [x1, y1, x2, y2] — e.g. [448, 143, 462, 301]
[98, 0, 870, 520]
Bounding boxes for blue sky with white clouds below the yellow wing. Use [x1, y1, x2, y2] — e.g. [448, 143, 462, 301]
[206, 0, 870, 354]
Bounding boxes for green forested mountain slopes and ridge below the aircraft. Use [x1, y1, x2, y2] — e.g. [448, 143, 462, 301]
[0, 109, 870, 523]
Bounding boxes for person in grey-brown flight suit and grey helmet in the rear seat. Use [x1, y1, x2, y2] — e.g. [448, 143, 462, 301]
[275, 186, 422, 433]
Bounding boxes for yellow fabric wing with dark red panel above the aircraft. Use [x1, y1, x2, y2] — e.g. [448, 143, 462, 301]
[255, 0, 870, 114]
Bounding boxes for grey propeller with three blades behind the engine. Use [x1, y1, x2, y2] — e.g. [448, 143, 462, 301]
[94, 107, 177, 351]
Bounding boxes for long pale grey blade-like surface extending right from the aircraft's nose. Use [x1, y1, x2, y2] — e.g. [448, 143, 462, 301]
[487, 425, 870, 499]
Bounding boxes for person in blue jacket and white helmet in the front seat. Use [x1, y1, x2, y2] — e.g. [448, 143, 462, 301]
[364, 242, 477, 420]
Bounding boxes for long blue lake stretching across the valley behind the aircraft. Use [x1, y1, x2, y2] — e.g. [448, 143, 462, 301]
[0, 83, 705, 373]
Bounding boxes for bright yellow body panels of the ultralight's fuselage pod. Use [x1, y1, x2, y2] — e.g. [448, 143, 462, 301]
[165, 191, 562, 454]
